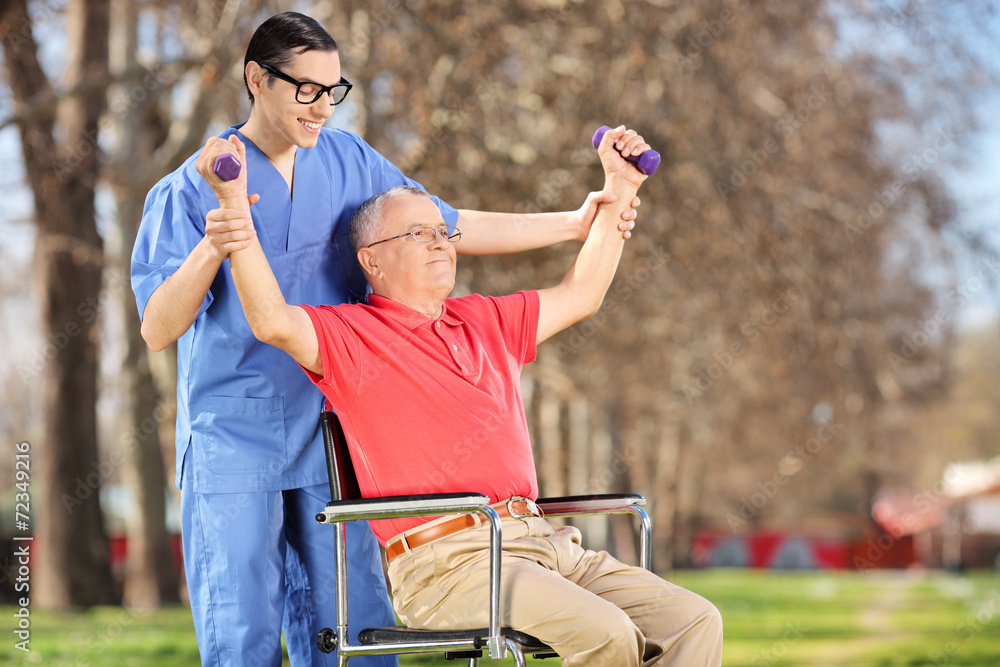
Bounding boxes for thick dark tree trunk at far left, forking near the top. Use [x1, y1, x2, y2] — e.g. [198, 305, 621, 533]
[0, 0, 117, 609]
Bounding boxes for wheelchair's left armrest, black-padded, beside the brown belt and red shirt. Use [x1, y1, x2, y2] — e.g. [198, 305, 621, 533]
[316, 493, 490, 523]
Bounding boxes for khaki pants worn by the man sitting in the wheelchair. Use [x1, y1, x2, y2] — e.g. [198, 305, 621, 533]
[388, 517, 722, 667]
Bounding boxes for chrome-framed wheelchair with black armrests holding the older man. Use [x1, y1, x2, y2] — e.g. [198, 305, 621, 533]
[316, 411, 652, 667]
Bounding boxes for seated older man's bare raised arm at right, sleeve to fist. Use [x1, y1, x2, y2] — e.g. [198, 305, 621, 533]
[536, 127, 649, 343]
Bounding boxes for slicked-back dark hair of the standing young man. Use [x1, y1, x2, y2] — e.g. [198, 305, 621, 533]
[243, 12, 337, 106]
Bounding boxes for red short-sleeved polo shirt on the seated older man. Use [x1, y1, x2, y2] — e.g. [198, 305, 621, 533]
[301, 292, 538, 544]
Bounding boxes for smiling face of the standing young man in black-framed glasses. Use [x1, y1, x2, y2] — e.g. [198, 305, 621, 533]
[243, 50, 340, 156]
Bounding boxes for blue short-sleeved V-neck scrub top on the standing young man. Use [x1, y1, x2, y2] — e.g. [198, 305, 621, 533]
[132, 125, 458, 493]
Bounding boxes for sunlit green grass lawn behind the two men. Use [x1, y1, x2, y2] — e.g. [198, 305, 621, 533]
[0, 570, 1000, 667]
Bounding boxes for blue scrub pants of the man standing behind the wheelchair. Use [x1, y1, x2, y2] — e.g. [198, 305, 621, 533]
[181, 484, 398, 667]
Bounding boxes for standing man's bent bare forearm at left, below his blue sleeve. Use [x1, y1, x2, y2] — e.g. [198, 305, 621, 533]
[139, 238, 222, 352]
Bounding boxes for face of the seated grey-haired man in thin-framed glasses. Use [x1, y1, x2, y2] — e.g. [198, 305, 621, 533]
[358, 194, 456, 317]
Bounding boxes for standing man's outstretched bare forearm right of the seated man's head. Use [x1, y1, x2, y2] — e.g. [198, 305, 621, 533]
[455, 209, 580, 255]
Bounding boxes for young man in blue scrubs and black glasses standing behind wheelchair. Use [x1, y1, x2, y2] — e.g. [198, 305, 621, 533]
[132, 13, 638, 665]
